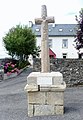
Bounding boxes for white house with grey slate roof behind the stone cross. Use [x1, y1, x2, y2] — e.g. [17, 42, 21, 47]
[31, 24, 79, 58]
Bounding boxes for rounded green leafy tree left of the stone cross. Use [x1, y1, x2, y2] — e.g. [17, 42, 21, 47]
[3, 25, 38, 60]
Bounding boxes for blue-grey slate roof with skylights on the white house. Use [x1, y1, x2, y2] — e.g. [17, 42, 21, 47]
[31, 24, 77, 36]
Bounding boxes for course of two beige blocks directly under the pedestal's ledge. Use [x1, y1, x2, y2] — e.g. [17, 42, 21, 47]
[27, 91, 64, 105]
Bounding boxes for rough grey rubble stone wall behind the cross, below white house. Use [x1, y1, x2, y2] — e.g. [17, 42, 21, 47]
[33, 59, 83, 86]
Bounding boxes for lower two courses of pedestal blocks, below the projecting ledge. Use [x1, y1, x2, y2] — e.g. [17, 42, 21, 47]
[27, 90, 64, 117]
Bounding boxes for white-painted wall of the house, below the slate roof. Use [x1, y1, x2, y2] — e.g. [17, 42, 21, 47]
[37, 36, 78, 58]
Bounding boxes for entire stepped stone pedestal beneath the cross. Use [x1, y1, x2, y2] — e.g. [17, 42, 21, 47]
[25, 72, 66, 117]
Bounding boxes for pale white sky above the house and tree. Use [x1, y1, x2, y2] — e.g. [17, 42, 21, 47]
[0, 0, 83, 58]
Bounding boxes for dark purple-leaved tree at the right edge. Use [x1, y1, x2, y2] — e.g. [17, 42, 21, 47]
[75, 8, 83, 50]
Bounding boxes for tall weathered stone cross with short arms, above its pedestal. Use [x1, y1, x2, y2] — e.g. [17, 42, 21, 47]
[35, 5, 54, 72]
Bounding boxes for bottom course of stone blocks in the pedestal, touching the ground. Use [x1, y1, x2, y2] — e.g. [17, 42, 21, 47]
[28, 104, 64, 117]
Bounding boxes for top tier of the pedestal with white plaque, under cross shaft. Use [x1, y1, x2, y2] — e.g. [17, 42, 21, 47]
[27, 72, 63, 85]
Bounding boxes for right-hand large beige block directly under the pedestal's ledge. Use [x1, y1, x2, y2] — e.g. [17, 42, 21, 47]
[47, 92, 64, 105]
